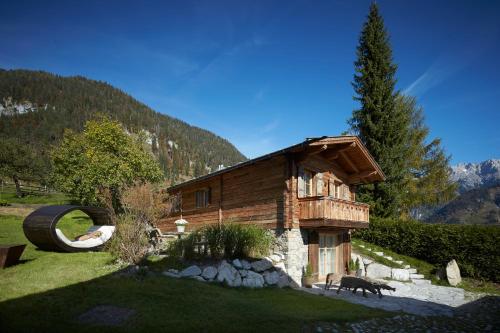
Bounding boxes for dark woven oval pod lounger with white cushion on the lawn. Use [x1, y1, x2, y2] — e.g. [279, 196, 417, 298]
[23, 205, 115, 252]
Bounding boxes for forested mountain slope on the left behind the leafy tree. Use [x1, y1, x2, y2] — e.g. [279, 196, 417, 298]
[0, 69, 246, 182]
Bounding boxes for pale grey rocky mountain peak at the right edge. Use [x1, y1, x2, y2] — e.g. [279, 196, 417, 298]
[451, 159, 500, 193]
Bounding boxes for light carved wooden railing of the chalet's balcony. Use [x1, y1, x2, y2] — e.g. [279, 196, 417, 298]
[299, 197, 370, 223]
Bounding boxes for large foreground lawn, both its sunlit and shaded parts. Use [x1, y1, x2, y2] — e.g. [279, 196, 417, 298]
[0, 212, 388, 332]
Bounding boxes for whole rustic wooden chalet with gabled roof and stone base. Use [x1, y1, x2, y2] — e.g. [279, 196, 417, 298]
[159, 136, 385, 284]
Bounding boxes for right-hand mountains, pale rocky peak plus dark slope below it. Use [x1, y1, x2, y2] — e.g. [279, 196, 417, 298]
[426, 159, 500, 225]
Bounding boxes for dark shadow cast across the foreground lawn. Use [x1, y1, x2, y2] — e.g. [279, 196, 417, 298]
[0, 254, 388, 332]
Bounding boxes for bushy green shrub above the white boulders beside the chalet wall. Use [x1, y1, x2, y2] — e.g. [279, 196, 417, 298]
[167, 223, 273, 259]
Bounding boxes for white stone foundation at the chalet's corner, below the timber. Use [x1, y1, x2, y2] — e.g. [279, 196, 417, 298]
[274, 228, 309, 287]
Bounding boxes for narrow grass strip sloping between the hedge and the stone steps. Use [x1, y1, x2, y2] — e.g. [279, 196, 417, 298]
[352, 238, 500, 295]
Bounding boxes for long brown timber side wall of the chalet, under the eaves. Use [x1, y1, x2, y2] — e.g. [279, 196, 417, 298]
[158, 156, 288, 231]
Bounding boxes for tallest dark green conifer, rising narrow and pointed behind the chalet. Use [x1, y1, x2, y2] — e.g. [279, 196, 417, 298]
[349, 3, 410, 216]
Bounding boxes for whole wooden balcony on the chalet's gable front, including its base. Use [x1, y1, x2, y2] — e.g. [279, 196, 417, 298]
[299, 197, 370, 228]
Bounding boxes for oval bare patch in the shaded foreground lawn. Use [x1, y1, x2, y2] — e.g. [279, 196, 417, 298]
[78, 305, 135, 326]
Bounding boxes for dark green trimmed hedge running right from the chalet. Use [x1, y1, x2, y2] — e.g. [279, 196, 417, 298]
[354, 218, 500, 282]
